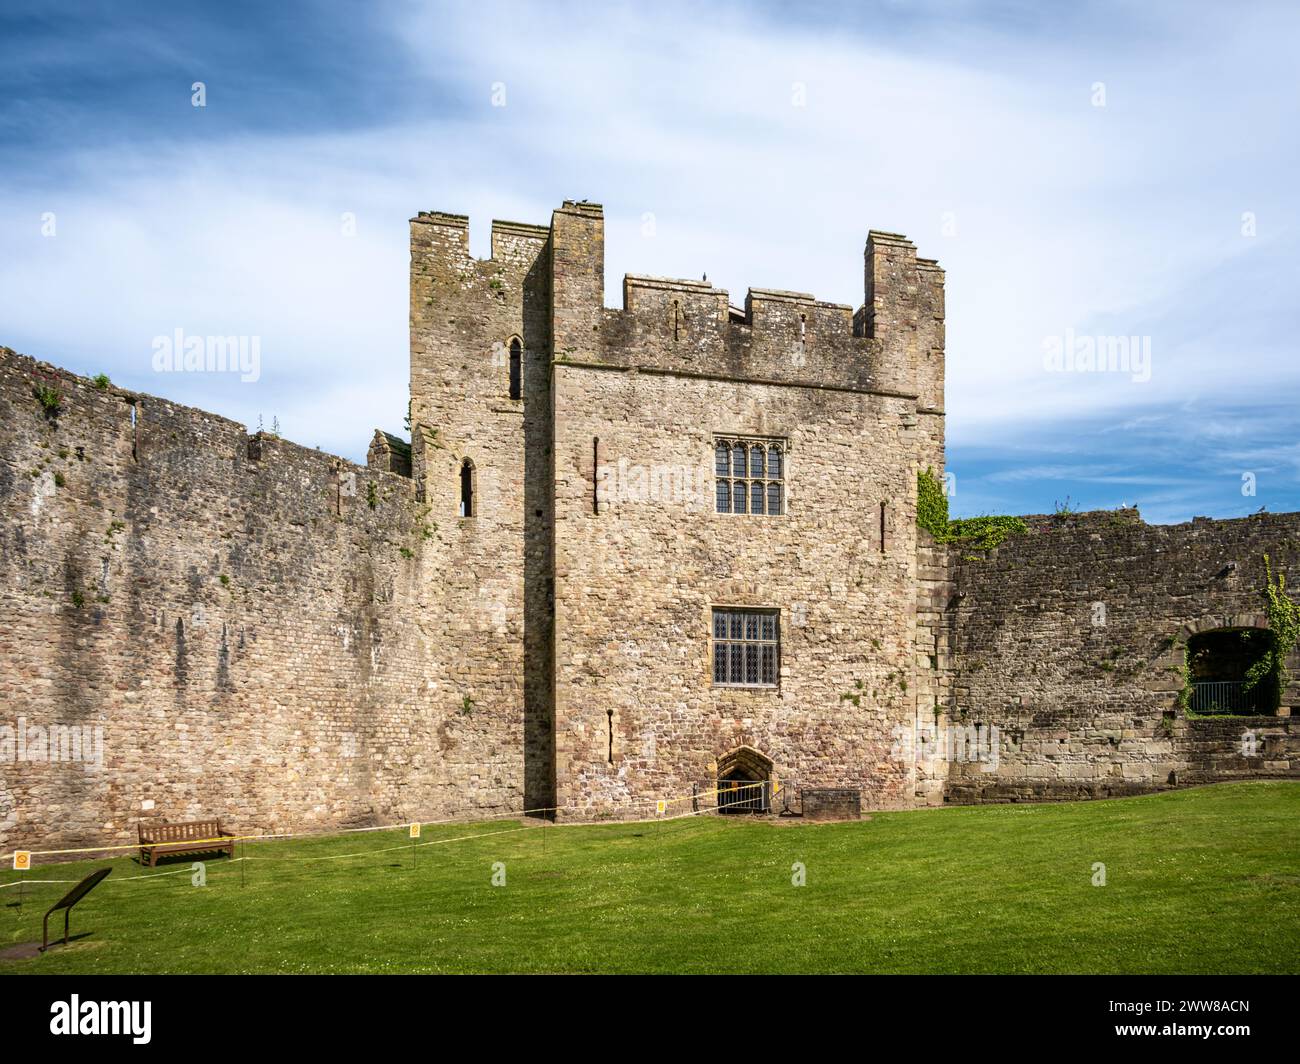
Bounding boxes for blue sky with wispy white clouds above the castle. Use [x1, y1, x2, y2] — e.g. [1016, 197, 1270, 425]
[0, 0, 1300, 522]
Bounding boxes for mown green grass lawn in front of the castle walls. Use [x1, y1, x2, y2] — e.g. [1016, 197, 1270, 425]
[0, 782, 1300, 973]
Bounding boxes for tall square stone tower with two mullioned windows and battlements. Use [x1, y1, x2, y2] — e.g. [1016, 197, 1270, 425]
[411, 202, 944, 812]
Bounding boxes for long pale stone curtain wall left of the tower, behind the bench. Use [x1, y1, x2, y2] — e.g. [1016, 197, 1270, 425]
[0, 349, 523, 848]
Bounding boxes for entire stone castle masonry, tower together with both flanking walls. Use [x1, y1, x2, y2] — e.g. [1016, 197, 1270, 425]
[0, 195, 1300, 848]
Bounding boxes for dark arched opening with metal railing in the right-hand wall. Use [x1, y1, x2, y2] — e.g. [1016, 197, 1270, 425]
[1187, 628, 1282, 714]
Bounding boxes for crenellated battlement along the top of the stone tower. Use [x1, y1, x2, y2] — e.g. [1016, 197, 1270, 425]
[411, 199, 944, 414]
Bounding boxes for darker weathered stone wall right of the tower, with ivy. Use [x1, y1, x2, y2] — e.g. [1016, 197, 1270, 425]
[945, 510, 1300, 801]
